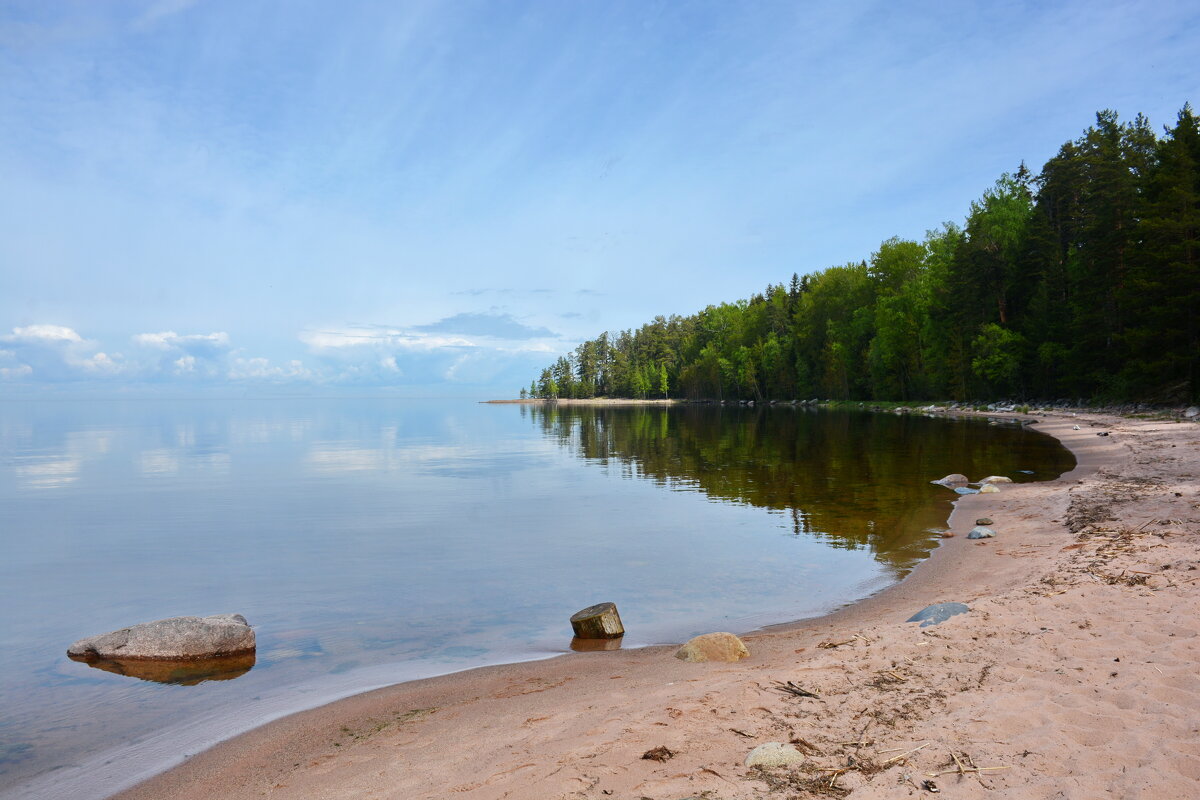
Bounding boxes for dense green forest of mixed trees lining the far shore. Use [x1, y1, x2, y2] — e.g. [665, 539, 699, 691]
[530, 106, 1200, 403]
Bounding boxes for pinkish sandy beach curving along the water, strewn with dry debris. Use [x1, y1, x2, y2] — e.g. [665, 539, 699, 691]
[118, 415, 1200, 800]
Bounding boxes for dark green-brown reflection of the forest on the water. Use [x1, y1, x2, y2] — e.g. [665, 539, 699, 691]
[528, 404, 1074, 572]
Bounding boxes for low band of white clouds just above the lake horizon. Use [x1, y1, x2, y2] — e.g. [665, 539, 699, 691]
[0, 313, 563, 390]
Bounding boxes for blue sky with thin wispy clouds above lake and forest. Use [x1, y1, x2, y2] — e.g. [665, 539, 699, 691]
[0, 0, 1200, 398]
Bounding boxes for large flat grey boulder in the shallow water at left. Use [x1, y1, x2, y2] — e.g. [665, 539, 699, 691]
[67, 614, 254, 661]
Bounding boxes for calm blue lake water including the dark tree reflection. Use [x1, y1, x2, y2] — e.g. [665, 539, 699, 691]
[0, 399, 1074, 799]
